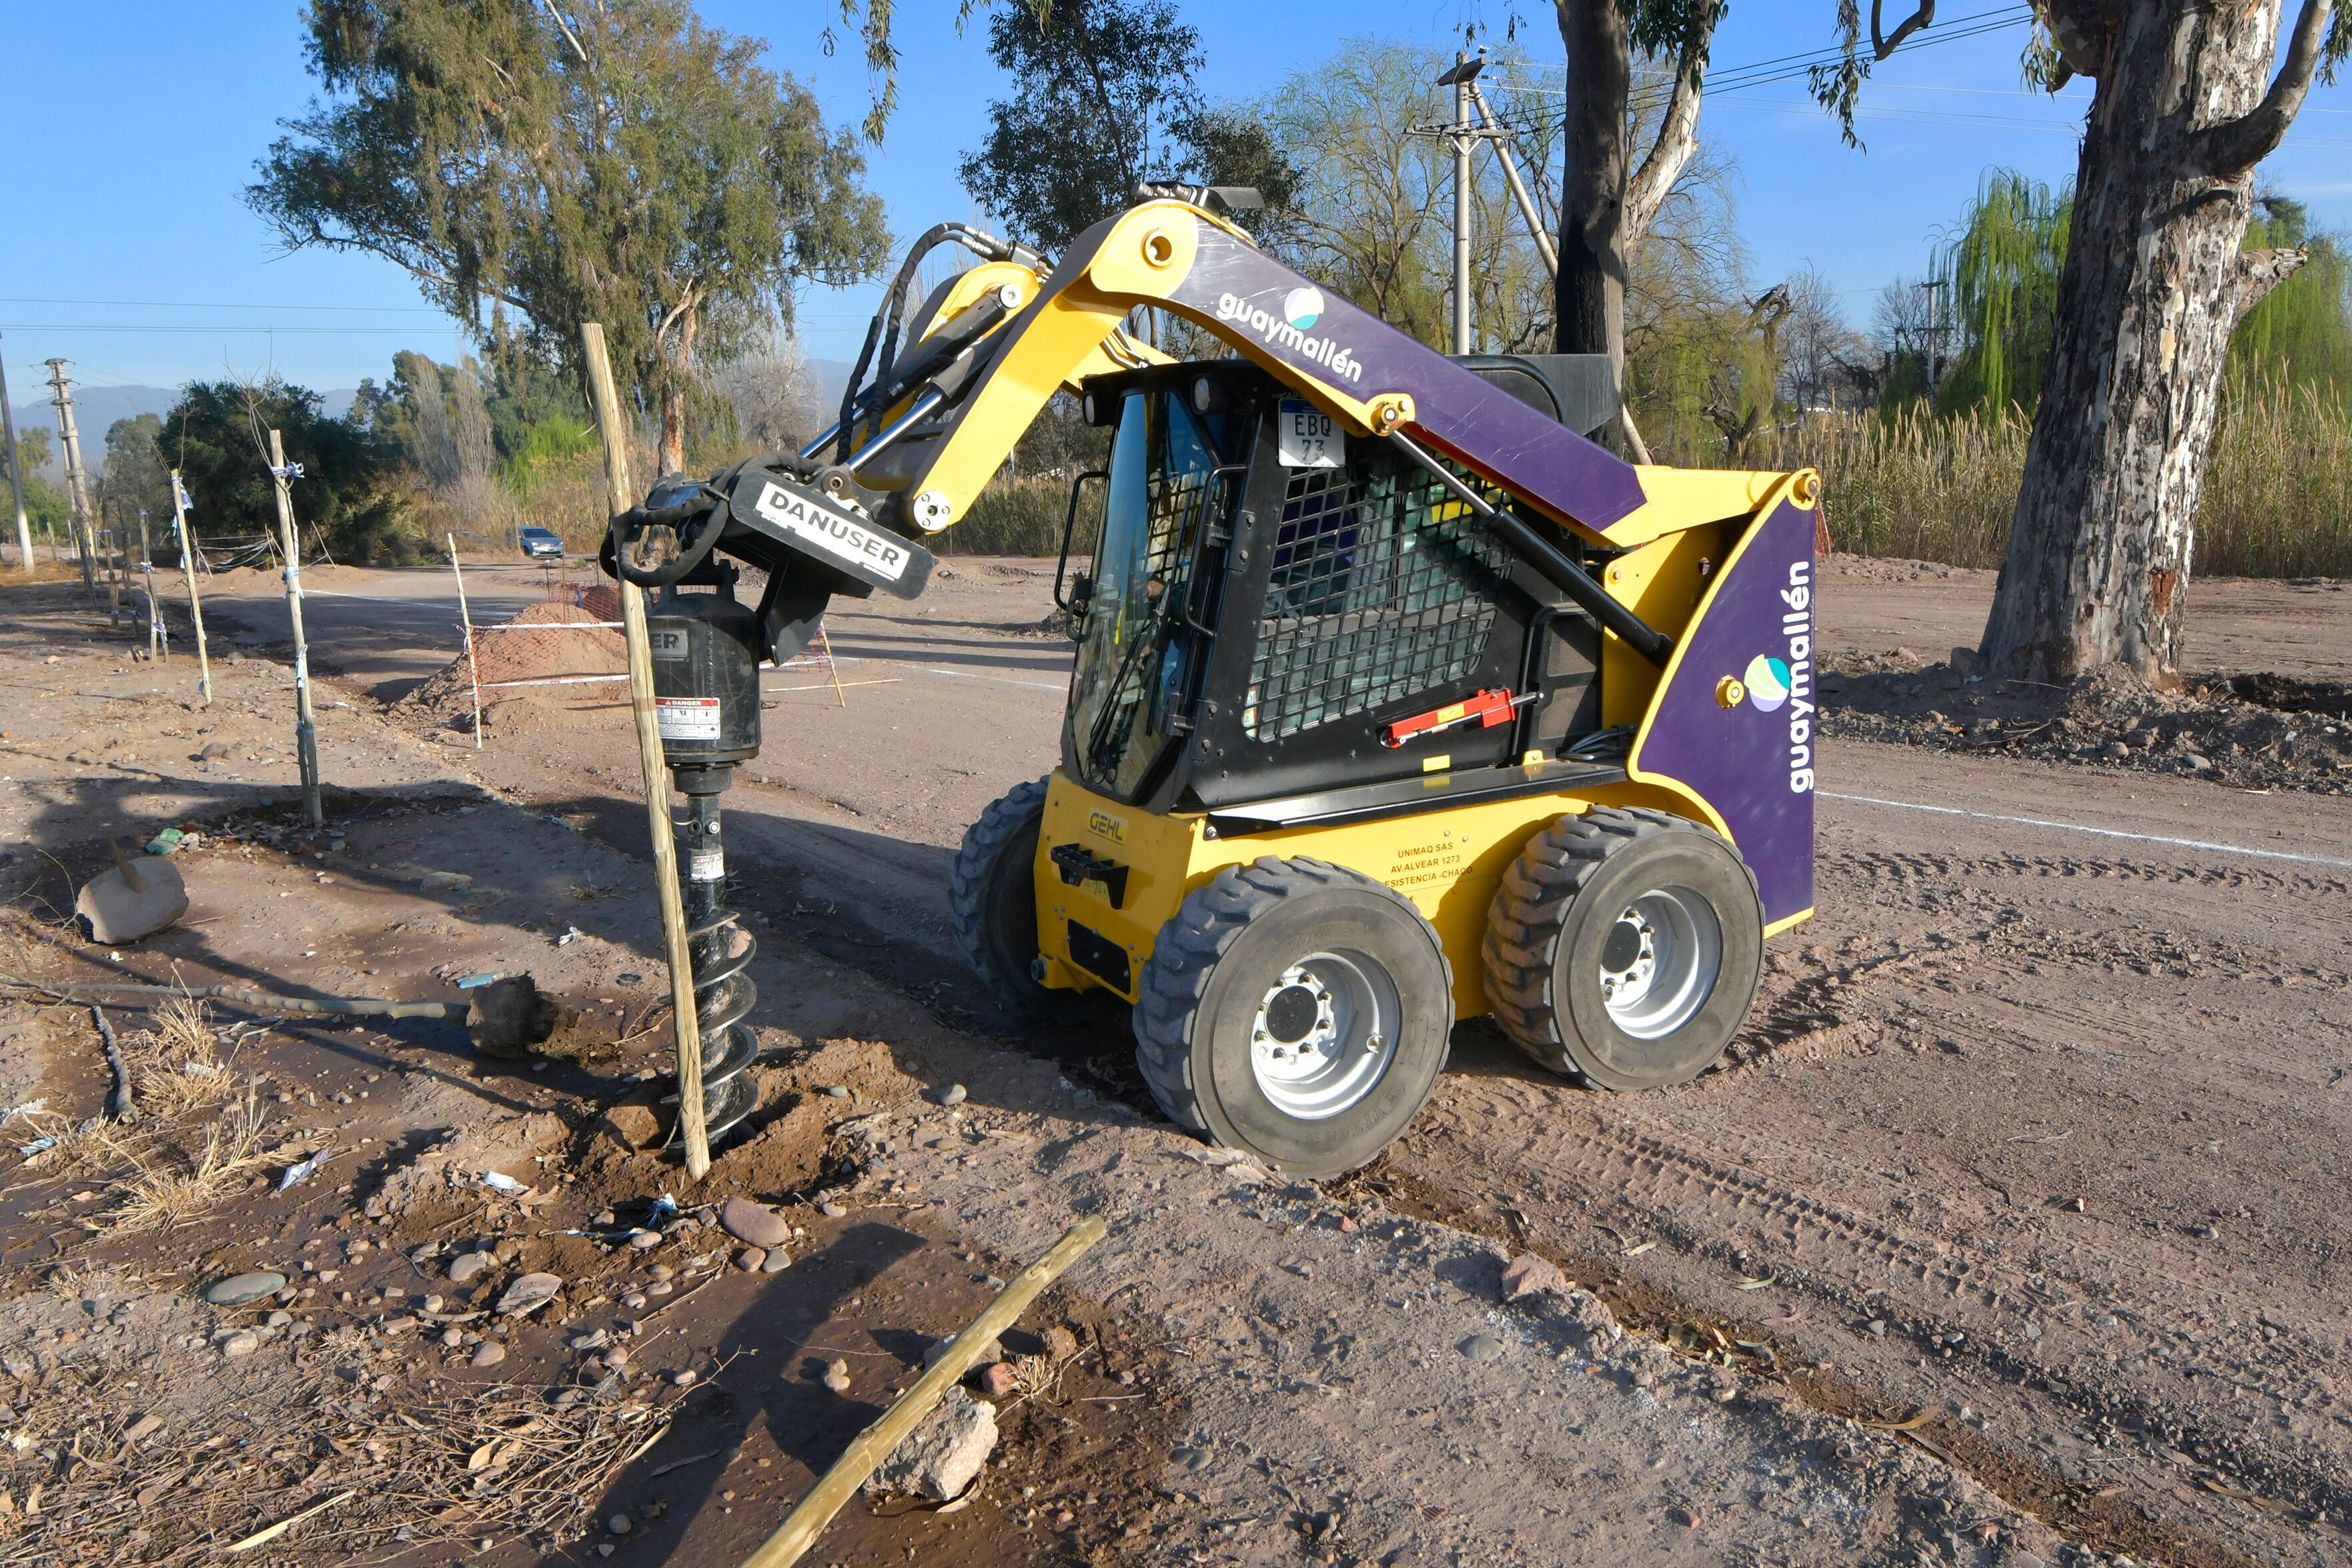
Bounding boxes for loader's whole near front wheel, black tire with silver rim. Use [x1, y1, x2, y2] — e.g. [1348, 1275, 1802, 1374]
[1134, 856, 1453, 1178]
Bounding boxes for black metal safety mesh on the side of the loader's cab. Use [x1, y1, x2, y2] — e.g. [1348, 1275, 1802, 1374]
[1242, 447, 1510, 740]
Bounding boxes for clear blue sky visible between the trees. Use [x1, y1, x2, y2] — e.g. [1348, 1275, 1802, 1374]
[0, 0, 2352, 404]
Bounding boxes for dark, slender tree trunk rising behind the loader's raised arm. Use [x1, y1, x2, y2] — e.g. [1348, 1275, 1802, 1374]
[1557, 0, 1632, 378]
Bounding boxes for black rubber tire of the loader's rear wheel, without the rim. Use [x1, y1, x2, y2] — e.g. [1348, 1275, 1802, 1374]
[1482, 806, 1764, 1093]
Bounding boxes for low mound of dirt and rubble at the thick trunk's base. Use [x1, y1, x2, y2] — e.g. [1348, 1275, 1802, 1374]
[1820, 649, 2352, 794]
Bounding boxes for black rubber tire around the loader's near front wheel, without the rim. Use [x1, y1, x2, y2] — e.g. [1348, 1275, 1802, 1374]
[1134, 856, 1453, 1178]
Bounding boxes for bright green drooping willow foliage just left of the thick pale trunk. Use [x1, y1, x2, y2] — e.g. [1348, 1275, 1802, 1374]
[1936, 169, 2075, 414]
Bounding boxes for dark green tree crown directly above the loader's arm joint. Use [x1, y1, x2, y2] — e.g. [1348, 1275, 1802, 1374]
[960, 0, 1202, 254]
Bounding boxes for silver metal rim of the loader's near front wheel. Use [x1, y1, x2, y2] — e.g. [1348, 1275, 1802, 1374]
[1249, 952, 1399, 1121]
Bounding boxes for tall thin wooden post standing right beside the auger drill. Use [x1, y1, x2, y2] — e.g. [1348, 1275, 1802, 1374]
[581, 322, 710, 1180]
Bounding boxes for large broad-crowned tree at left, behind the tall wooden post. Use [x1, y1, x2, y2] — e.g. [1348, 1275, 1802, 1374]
[247, 0, 887, 468]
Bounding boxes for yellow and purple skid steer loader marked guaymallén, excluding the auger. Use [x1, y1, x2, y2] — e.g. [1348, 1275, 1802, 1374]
[614, 188, 1818, 1175]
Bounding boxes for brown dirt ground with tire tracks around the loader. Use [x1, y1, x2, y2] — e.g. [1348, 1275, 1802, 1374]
[0, 560, 2352, 1563]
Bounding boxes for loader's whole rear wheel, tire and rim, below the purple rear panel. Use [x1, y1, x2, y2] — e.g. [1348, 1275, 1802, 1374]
[1482, 806, 1764, 1090]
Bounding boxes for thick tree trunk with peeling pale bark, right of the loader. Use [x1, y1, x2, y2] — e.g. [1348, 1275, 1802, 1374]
[1980, 0, 2329, 682]
